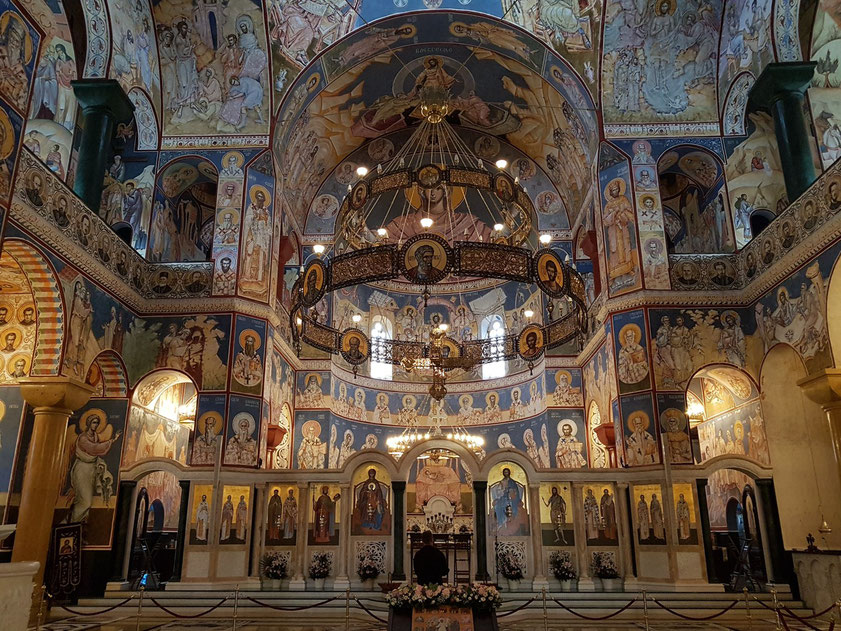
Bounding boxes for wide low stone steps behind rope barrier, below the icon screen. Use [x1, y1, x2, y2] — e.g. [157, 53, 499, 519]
[50, 583, 826, 631]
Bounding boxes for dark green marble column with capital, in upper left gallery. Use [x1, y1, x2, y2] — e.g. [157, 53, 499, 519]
[71, 79, 134, 212]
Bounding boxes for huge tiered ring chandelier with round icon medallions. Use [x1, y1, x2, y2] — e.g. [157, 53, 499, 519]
[290, 89, 587, 402]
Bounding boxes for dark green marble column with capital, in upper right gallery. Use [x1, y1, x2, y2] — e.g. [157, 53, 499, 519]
[748, 61, 817, 202]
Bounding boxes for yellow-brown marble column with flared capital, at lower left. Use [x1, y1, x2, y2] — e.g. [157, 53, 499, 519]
[12, 377, 93, 586]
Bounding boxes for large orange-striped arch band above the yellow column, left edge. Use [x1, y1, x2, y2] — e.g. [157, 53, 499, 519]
[3, 239, 65, 377]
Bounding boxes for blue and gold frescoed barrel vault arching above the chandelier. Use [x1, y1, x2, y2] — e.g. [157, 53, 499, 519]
[274, 12, 599, 235]
